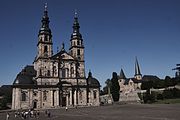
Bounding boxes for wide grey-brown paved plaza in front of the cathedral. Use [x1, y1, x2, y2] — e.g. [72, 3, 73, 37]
[0, 104, 180, 120]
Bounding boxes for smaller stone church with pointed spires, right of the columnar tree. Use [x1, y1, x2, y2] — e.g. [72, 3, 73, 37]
[118, 58, 142, 102]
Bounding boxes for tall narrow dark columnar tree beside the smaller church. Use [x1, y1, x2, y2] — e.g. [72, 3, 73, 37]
[111, 72, 120, 101]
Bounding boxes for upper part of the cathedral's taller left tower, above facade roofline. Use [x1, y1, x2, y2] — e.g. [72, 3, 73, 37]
[36, 4, 53, 60]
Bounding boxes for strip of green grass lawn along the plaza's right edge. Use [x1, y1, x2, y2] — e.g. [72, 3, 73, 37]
[155, 98, 180, 104]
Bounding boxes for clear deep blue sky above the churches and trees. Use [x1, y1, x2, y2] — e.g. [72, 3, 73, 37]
[0, 0, 180, 86]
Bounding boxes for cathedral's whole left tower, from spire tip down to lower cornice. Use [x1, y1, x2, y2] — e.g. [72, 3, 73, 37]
[34, 4, 53, 84]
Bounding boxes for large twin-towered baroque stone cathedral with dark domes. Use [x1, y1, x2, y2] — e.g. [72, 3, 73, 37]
[12, 5, 100, 109]
